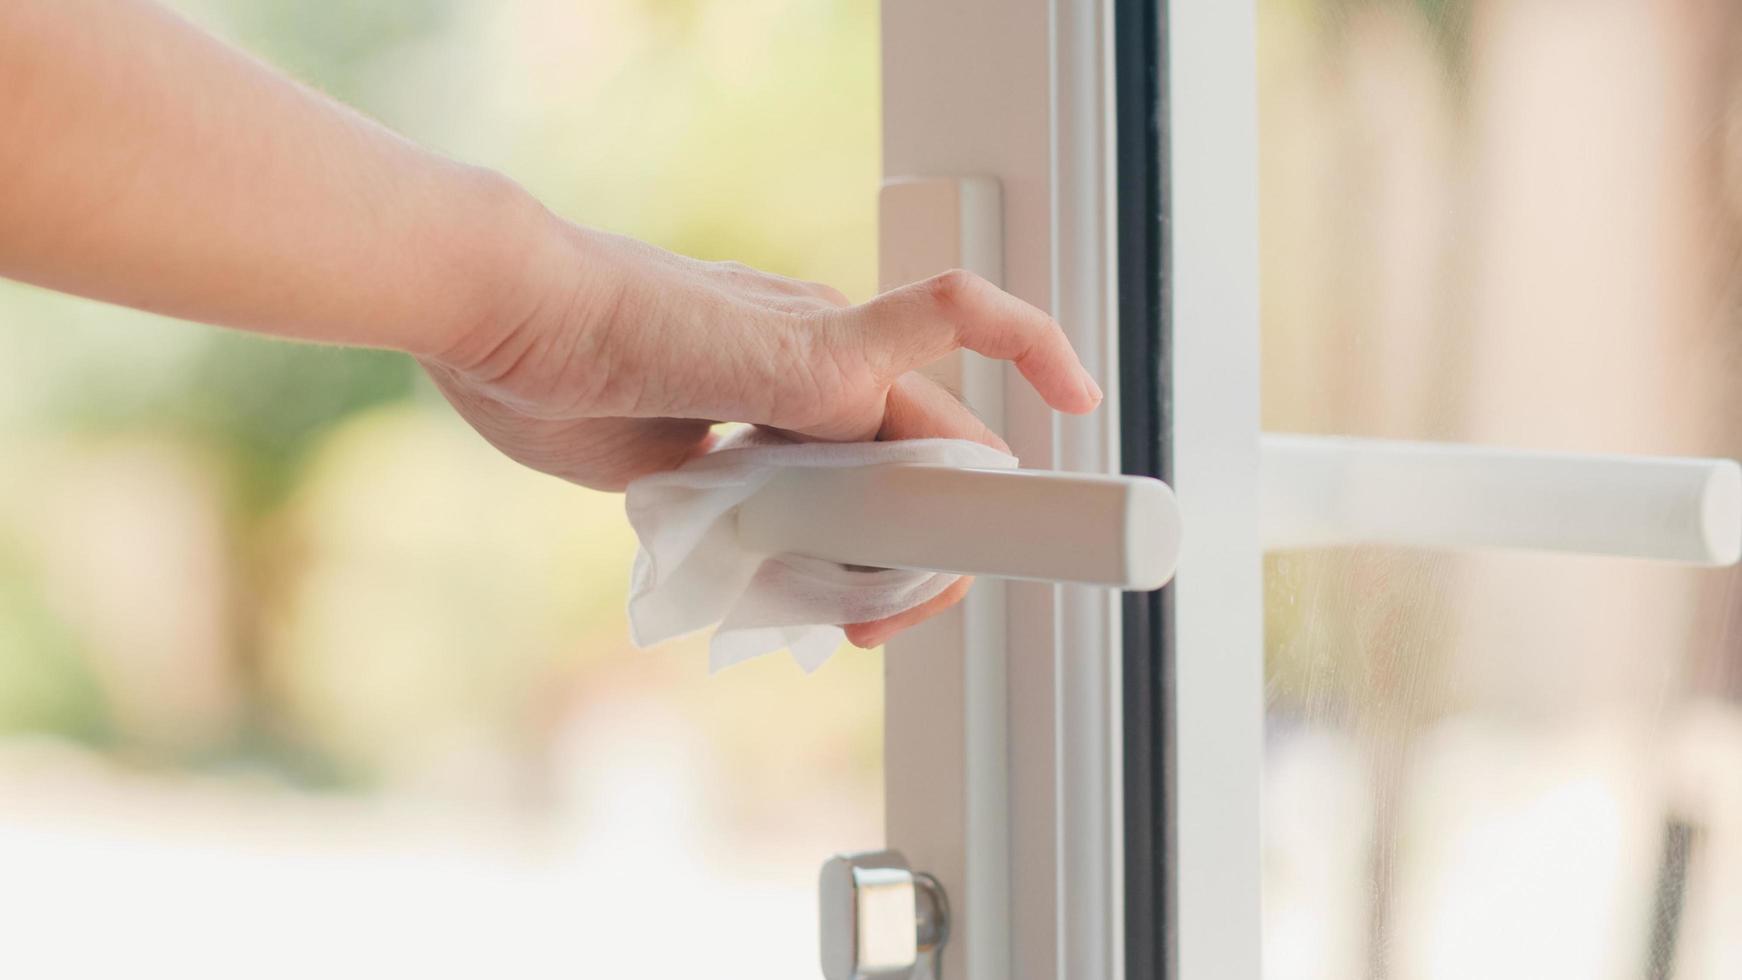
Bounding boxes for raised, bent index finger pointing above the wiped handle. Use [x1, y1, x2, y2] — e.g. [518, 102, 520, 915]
[852, 270, 1101, 414]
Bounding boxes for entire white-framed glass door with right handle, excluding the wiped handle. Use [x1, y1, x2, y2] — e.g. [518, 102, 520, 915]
[860, 0, 1742, 978]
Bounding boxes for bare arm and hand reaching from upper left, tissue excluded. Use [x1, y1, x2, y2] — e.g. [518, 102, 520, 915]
[0, 0, 1101, 646]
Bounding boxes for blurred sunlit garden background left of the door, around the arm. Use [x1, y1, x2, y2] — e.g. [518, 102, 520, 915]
[0, 0, 881, 978]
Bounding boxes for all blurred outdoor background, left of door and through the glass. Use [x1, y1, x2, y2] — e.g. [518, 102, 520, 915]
[13, 0, 1742, 980]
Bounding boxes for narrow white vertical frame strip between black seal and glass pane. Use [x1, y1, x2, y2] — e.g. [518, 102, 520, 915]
[1167, 0, 1265, 980]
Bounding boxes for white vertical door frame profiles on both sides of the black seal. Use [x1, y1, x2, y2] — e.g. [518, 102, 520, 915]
[883, 0, 1263, 980]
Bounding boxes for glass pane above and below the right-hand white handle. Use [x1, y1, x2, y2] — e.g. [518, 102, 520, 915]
[1259, 0, 1742, 980]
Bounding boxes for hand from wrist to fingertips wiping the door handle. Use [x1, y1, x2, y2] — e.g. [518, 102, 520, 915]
[422, 218, 1101, 646]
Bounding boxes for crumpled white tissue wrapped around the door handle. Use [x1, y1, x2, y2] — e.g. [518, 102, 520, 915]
[625, 430, 1016, 672]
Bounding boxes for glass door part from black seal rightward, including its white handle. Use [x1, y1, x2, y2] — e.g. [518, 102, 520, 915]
[1117, 0, 1742, 978]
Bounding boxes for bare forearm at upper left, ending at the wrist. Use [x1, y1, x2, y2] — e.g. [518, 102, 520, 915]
[0, 0, 545, 353]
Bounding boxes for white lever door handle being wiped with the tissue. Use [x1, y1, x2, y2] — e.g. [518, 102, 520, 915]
[739, 465, 1179, 590]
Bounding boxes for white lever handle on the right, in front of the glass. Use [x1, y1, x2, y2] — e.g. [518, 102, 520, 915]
[1261, 435, 1742, 566]
